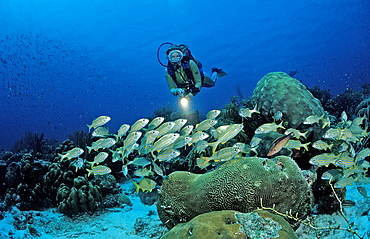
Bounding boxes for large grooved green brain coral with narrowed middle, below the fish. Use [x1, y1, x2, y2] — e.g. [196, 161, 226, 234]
[157, 156, 312, 228]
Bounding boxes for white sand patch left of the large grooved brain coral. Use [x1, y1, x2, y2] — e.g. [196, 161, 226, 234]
[0, 183, 167, 239]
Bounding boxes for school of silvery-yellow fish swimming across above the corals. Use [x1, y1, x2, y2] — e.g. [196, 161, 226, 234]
[59, 106, 370, 192]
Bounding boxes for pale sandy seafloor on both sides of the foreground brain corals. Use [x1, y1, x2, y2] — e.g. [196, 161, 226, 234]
[0, 182, 370, 239]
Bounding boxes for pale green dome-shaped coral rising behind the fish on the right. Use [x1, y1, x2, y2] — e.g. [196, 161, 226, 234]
[252, 72, 324, 128]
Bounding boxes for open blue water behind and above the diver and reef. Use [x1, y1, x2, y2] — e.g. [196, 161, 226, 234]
[0, 0, 370, 149]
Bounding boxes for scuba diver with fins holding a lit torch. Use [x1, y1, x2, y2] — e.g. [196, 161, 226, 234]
[157, 43, 226, 99]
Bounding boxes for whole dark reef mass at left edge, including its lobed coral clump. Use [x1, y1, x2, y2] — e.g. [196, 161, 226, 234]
[1, 137, 119, 215]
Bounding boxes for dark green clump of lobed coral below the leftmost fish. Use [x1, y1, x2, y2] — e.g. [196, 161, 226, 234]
[44, 140, 119, 216]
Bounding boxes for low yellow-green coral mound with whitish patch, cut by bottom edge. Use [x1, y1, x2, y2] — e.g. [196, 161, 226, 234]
[162, 210, 297, 239]
